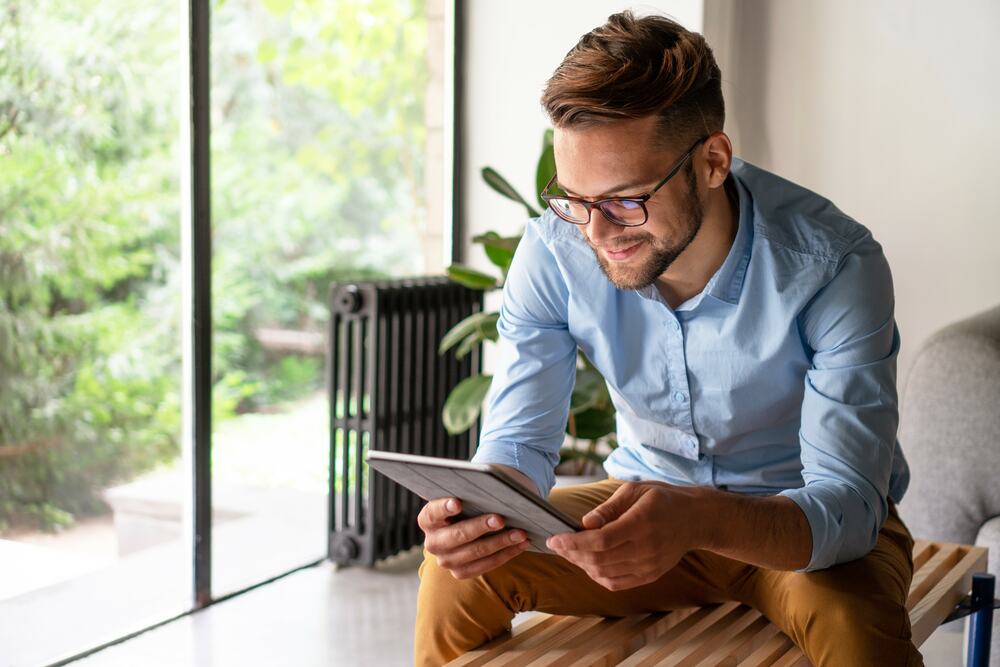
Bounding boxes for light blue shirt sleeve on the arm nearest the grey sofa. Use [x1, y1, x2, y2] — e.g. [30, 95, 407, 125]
[781, 236, 899, 571]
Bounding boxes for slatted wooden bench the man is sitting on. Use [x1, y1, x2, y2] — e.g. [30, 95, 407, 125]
[448, 540, 993, 667]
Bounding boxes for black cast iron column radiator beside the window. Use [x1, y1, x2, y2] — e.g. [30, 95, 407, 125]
[327, 276, 483, 565]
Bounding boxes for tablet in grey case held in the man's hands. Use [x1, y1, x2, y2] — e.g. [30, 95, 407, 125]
[365, 450, 583, 554]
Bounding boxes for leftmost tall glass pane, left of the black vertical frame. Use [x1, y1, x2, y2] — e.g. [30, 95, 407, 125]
[0, 0, 191, 664]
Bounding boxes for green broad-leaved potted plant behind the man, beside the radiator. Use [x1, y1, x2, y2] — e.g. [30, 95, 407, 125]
[439, 129, 617, 481]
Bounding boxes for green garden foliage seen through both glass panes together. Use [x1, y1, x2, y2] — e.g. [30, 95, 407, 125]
[0, 0, 428, 530]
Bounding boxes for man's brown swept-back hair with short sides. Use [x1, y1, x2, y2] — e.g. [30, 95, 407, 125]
[542, 11, 726, 149]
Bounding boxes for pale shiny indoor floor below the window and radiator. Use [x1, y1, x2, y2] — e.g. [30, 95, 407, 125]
[73, 553, 962, 667]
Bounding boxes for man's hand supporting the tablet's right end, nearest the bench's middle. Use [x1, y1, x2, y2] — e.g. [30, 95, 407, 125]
[546, 482, 696, 591]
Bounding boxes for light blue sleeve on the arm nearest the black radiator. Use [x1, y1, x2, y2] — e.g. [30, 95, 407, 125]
[472, 221, 576, 496]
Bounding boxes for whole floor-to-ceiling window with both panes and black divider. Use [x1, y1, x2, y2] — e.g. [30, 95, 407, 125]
[0, 0, 451, 664]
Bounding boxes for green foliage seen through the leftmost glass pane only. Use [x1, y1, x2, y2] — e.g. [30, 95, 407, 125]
[0, 1, 180, 529]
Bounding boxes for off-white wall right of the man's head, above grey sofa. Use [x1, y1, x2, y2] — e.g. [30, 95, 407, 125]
[705, 0, 1000, 380]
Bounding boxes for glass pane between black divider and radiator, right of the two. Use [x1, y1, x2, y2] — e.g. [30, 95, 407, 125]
[212, 0, 445, 595]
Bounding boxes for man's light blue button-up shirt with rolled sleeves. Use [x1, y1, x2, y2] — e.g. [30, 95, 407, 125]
[473, 160, 909, 571]
